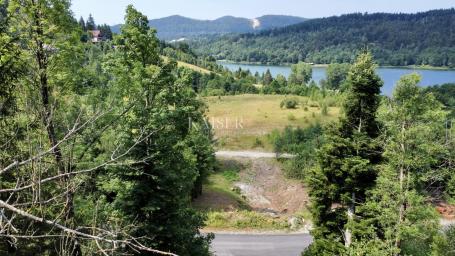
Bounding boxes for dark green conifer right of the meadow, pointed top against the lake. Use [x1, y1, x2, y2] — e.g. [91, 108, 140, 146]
[305, 53, 382, 255]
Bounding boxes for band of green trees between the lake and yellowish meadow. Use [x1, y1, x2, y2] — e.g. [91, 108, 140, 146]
[185, 62, 350, 96]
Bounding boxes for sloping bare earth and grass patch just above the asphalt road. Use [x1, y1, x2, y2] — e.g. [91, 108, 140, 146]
[193, 157, 311, 233]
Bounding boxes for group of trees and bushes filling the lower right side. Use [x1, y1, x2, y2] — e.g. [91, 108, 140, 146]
[274, 54, 455, 256]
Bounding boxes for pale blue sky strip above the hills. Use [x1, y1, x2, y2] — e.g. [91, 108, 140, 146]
[72, 0, 455, 25]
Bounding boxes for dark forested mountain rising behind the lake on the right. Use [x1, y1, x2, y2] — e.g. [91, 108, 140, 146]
[194, 8, 455, 67]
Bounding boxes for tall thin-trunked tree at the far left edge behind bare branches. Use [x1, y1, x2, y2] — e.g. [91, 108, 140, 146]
[1, 0, 91, 255]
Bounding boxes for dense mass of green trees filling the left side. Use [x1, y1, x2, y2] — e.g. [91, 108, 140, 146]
[0, 0, 214, 255]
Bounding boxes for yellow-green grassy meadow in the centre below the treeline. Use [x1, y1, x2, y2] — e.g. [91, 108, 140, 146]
[204, 94, 340, 151]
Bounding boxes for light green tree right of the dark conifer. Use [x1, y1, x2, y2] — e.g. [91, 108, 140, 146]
[352, 74, 448, 255]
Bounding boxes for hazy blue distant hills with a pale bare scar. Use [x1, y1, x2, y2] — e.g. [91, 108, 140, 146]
[112, 15, 306, 40]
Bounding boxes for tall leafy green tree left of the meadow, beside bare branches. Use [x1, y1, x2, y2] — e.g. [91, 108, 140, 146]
[100, 5, 213, 255]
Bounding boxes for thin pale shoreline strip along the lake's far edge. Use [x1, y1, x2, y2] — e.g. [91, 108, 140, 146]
[216, 60, 455, 71]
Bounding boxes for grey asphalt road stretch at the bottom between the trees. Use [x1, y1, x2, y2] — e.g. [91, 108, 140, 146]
[212, 234, 312, 256]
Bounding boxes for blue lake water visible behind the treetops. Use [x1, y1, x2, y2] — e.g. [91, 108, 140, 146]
[218, 61, 455, 95]
